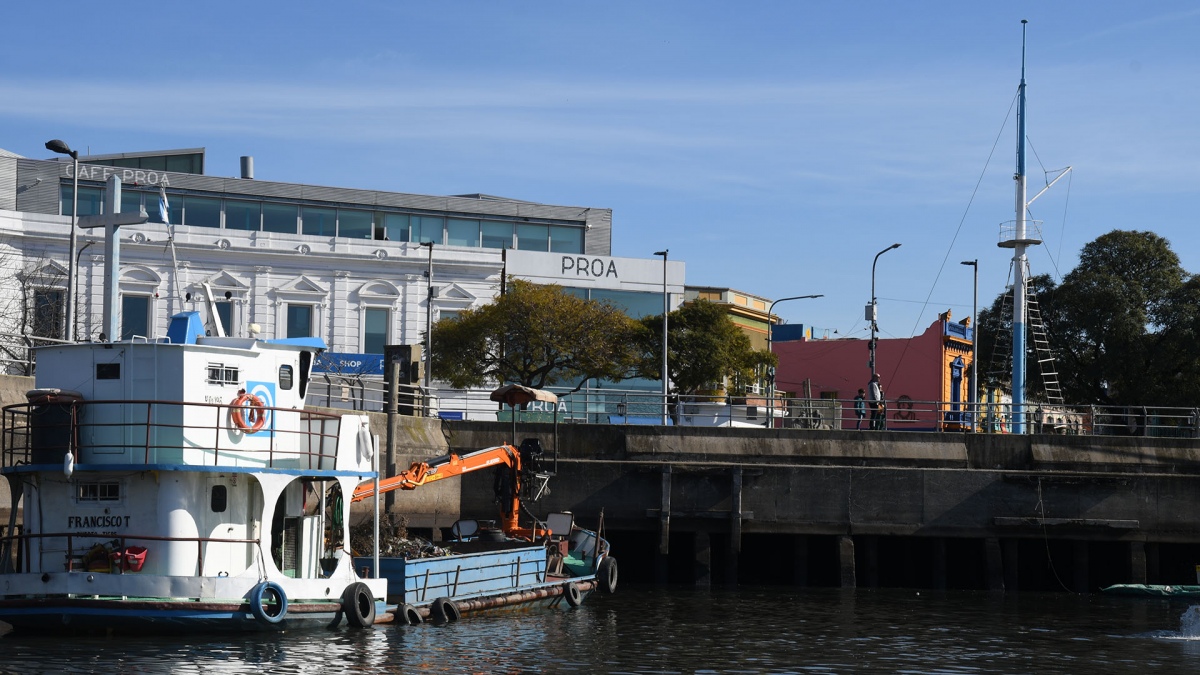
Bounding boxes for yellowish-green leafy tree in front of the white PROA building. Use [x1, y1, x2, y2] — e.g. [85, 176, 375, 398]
[433, 280, 642, 390]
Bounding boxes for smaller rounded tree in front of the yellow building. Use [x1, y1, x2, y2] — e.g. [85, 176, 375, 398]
[641, 300, 776, 394]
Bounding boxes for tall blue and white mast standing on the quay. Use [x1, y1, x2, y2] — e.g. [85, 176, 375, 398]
[1013, 19, 1028, 434]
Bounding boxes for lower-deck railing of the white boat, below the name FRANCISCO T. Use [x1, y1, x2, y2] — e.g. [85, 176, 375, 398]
[0, 532, 263, 577]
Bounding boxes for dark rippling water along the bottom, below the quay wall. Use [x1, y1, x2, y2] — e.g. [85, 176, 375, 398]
[0, 586, 1200, 675]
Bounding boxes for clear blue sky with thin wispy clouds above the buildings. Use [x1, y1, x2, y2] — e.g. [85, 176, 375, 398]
[0, 0, 1200, 336]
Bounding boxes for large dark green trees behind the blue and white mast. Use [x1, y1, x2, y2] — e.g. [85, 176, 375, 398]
[978, 229, 1185, 406]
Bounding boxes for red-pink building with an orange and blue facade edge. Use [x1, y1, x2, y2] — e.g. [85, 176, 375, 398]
[772, 311, 974, 430]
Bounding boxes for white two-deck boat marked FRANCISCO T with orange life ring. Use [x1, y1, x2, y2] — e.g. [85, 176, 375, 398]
[0, 312, 388, 631]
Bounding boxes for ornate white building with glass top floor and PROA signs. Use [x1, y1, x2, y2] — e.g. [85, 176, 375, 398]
[0, 149, 685, 413]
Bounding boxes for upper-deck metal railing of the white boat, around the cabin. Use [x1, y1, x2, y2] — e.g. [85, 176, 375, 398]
[0, 400, 341, 470]
